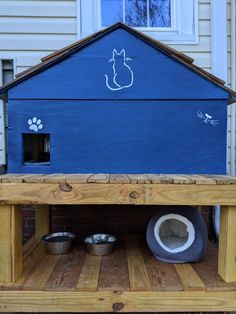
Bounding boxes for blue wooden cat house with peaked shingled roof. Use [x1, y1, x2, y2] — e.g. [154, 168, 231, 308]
[0, 23, 236, 174]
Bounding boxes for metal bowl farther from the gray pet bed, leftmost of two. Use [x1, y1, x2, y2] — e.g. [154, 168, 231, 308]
[42, 232, 75, 254]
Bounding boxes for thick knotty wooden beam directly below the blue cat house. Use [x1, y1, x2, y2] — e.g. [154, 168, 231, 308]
[0, 183, 236, 205]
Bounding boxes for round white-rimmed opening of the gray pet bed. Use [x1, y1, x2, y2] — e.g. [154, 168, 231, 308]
[154, 214, 195, 253]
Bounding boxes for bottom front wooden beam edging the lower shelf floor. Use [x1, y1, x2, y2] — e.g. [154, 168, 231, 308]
[0, 291, 236, 312]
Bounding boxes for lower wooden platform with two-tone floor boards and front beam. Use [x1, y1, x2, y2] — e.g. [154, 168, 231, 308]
[0, 235, 236, 312]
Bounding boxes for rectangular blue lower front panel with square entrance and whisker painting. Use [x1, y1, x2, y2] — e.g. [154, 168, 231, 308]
[8, 100, 227, 174]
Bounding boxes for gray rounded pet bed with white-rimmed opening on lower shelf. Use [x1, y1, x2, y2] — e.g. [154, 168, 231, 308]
[146, 206, 208, 263]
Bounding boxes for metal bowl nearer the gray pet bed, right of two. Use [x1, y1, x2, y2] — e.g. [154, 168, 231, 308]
[84, 233, 116, 255]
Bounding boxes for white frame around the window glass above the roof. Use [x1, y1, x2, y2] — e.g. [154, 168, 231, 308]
[77, 0, 198, 44]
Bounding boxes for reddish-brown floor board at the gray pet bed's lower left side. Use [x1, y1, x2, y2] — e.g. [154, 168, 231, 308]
[140, 239, 184, 291]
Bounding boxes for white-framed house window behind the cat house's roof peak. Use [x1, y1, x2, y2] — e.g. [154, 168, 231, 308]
[80, 0, 198, 44]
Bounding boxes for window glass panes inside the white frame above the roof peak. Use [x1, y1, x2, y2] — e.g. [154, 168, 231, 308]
[101, 0, 171, 28]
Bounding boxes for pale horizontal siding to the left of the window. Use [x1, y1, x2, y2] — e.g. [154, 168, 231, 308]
[0, 0, 78, 73]
